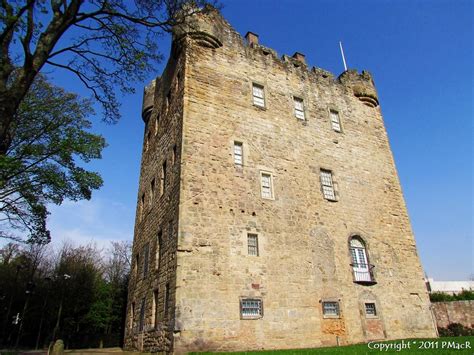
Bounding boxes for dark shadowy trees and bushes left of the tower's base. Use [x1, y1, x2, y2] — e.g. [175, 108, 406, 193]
[0, 242, 131, 349]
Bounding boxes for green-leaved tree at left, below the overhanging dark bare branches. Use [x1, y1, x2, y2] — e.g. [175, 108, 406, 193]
[0, 75, 105, 243]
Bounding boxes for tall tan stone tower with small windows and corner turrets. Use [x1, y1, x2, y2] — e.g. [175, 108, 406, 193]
[125, 8, 436, 353]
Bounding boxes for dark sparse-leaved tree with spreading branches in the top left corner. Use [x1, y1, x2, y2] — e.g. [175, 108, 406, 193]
[0, 0, 215, 156]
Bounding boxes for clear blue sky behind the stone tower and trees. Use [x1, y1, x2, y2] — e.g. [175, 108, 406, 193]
[43, 0, 474, 280]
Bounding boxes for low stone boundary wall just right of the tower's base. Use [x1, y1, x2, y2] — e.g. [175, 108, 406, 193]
[432, 301, 474, 328]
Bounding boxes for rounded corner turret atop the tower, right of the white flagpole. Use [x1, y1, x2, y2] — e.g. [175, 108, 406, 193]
[338, 69, 379, 107]
